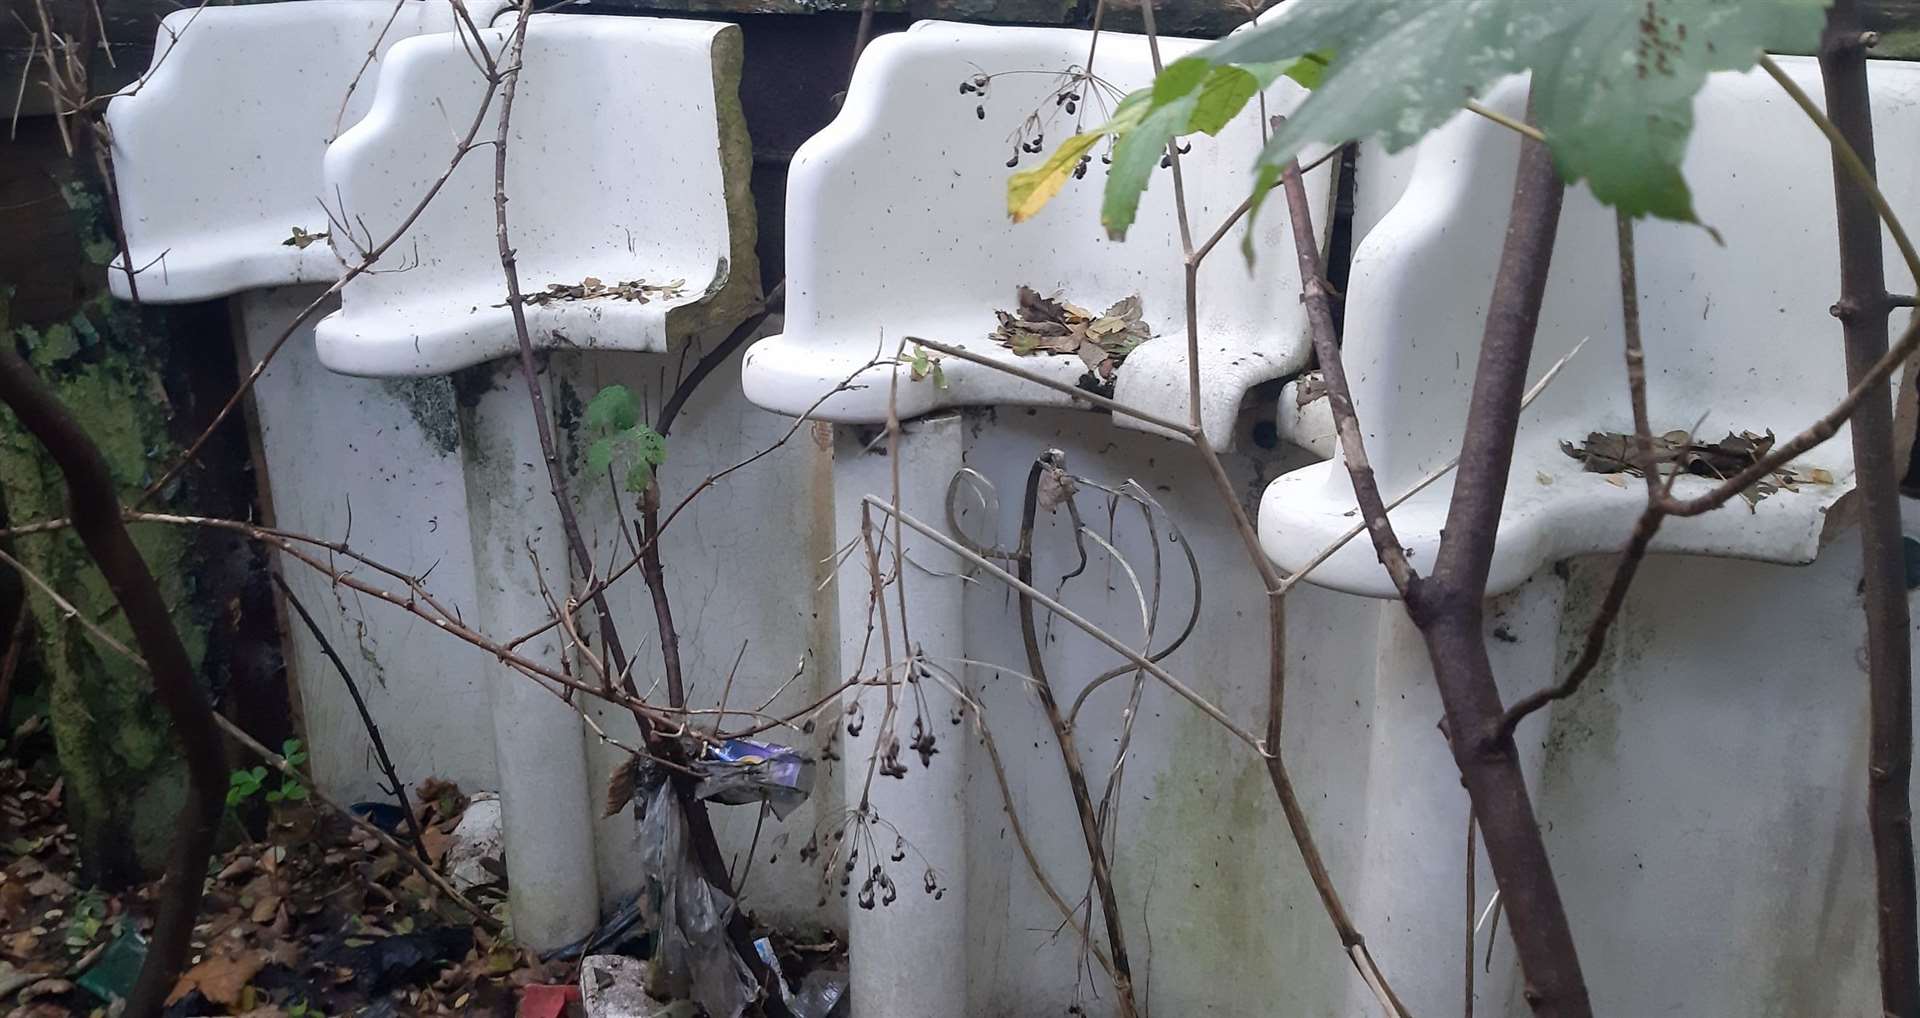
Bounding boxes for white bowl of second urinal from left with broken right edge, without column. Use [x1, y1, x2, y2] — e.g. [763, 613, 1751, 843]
[317, 15, 760, 376]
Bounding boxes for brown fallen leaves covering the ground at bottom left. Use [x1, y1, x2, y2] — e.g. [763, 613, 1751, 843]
[0, 722, 574, 1018]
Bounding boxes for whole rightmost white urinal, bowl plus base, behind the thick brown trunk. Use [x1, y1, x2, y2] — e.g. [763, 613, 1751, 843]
[1260, 58, 1920, 1014]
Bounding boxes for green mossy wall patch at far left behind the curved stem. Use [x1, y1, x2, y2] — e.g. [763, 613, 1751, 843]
[0, 171, 217, 885]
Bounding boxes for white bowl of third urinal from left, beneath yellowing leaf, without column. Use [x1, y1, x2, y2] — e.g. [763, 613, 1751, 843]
[743, 21, 1332, 442]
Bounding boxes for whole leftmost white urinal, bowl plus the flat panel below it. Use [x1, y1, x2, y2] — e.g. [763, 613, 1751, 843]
[108, 0, 501, 822]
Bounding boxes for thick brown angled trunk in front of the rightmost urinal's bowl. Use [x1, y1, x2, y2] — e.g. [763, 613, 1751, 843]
[1405, 105, 1594, 1018]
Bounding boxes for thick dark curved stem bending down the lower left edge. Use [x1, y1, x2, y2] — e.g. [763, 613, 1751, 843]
[0, 344, 227, 1018]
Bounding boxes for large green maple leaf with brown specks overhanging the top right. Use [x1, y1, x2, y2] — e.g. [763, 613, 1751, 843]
[1075, 0, 1828, 236]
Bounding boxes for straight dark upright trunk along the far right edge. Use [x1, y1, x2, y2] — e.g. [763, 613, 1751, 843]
[1804, 0, 1920, 1016]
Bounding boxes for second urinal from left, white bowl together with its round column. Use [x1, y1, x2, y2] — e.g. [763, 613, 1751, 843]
[303, 15, 758, 947]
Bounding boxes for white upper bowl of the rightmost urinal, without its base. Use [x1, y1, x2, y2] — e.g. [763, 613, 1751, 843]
[1260, 58, 1920, 597]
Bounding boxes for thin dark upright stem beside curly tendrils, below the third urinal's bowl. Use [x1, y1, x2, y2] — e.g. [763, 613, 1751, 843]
[1013, 449, 1139, 1018]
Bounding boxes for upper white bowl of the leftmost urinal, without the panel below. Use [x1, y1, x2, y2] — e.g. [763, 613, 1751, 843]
[108, 0, 501, 302]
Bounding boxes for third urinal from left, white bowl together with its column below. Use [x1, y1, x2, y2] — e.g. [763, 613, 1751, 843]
[743, 21, 1332, 1018]
